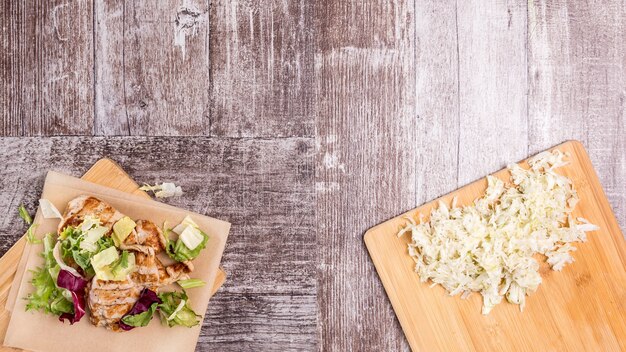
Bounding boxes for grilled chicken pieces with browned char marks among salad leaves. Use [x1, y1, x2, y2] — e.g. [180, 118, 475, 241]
[58, 196, 193, 331]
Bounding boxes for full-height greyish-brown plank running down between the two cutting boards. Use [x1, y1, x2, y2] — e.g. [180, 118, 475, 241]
[315, 1, 418, 351]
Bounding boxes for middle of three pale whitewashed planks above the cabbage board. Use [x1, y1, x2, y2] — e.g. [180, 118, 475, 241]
[456, 0, 528, 187]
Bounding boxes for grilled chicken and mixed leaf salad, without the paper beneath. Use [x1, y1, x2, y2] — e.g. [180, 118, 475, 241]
[26, 195, 209, 331]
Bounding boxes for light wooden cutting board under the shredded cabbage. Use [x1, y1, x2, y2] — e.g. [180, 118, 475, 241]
[365, 141, 626, 351]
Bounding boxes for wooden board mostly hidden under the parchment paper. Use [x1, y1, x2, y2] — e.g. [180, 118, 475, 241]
[0, 158, 226, 351]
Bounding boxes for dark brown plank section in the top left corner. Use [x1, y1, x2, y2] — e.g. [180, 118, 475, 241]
[0, 0, 93, 136]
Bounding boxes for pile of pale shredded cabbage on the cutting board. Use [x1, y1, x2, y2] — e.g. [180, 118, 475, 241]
[398, 150, 598, 314]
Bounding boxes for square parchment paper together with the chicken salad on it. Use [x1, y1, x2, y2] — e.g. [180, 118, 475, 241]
[3, 171, 230, 352]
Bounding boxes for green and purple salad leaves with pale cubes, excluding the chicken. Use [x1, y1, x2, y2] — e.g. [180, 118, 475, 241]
[19, 199, 209, 330]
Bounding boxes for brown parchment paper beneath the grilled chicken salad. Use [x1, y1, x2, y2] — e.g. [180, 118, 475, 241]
[4, 171, 230, 352]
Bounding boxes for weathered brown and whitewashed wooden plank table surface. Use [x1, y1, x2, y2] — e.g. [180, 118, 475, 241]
[0, 0, 626, 351]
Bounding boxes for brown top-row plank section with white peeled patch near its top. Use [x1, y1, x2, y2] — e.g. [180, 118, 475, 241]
[94, 0, 210, 136]
